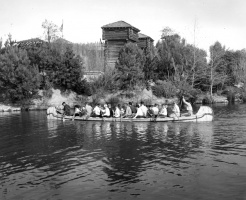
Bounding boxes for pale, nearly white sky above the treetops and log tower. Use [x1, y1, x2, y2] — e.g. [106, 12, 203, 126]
[0, 0, 246, 51]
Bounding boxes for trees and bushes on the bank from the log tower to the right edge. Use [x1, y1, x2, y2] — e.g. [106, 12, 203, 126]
[90, 28, 246, 103]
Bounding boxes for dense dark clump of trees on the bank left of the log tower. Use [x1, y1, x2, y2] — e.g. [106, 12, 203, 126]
[0, 34, 86, 101]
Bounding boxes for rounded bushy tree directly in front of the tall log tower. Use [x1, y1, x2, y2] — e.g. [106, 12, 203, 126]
[115, 43, 145, 90]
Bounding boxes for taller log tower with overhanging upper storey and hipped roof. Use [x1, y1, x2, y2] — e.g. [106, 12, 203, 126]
[102, 21, 140, 70]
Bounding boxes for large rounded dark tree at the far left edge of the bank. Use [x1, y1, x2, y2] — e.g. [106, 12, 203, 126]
[0, 46, 40, 101]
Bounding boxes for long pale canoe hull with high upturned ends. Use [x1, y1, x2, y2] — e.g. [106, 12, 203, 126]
[47, 106, 213, 122]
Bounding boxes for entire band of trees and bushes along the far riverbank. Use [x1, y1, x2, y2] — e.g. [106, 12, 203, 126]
[0, 21, 246, 107]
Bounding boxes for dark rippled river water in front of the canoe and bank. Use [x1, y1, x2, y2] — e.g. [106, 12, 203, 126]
[0, 104, 246, 200]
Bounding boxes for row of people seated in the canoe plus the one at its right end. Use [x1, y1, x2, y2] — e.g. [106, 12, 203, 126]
[56, 97, 193, 118]
